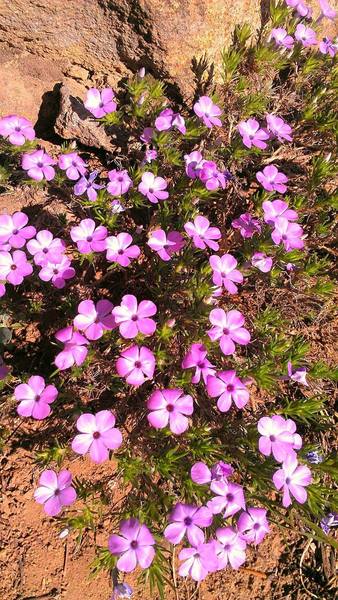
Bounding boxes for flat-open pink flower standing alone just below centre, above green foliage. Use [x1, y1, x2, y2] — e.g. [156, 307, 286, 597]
[147, 390, 194, 435]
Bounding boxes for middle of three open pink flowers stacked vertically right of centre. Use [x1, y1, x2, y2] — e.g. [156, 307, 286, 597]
[207, 308, 251, 356]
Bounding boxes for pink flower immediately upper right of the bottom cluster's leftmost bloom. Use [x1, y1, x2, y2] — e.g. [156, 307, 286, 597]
[164, 502, 213, 546]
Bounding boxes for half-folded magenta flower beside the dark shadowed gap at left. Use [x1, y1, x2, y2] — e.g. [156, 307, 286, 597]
[54, 326, 88, 371]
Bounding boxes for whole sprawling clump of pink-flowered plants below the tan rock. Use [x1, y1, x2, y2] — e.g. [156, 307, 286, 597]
[0, 0, 338, 598]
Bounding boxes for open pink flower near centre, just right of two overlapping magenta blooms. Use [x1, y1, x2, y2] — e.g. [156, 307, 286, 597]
[113, 294, 157, 339]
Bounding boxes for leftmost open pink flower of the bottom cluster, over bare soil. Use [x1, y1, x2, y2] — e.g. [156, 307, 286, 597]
[108, 518, 155, 573]
